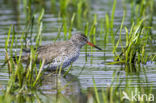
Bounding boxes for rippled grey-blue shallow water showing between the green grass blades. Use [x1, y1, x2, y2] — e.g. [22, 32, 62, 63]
[0, 0, 156, 103]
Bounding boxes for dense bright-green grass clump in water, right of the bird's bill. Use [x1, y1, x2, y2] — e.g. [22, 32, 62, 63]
[111, 19, 148, 64]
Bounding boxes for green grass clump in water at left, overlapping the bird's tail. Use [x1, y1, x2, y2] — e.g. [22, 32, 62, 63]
[1, 10, 44, 98]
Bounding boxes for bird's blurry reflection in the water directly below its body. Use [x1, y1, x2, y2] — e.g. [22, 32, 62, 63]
[40, 71, 86, 103]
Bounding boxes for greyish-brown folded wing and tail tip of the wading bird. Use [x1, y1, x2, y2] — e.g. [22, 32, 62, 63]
[17, 41, 71, 64]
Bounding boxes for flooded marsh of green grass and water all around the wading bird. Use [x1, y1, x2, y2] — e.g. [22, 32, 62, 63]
[0, 0, 156, 103]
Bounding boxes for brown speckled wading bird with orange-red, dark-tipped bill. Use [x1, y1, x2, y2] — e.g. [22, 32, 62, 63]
[18, 33, 102, 70]
